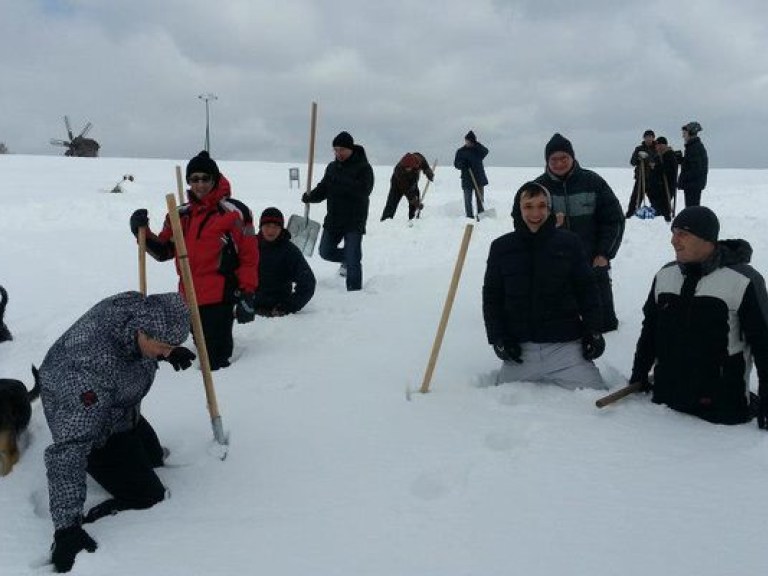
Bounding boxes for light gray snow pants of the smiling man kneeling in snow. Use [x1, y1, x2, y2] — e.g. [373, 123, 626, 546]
[496, 340, 608, 390]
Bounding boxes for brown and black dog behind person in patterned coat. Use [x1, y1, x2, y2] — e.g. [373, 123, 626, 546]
[0, 366, 40, 476]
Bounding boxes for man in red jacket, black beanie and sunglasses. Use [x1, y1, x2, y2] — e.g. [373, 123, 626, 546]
[130, 151, 259, 370]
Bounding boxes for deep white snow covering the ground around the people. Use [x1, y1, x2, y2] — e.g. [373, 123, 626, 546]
[0, 154, 768, 576]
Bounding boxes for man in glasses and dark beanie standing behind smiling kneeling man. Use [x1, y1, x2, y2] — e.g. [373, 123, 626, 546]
[536, 134, 624, 332]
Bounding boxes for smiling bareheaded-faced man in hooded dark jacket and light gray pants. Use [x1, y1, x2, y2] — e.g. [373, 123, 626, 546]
[483, 182, 605, 389]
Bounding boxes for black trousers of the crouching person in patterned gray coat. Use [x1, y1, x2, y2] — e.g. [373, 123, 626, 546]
[86, 416, 165, 510]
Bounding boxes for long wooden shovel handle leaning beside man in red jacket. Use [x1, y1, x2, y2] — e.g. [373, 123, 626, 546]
[165, 194, 229, 450]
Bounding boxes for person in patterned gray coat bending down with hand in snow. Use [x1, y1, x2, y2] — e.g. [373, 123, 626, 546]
[40, 292, 195, 572]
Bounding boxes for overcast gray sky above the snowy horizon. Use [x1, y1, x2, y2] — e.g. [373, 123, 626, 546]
[0, 0, 768, 169]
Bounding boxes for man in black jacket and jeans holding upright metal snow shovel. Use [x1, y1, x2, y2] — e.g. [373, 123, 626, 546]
[301, 132, 373, 292]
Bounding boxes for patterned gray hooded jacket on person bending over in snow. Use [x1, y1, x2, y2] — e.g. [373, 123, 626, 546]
[40, 292, 189, 529]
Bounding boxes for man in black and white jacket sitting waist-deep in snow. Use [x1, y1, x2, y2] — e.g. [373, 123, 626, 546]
[631, 206, 768, 429]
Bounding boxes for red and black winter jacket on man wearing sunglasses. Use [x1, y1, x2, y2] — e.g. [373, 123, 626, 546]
[147, 176, 259, 306]
